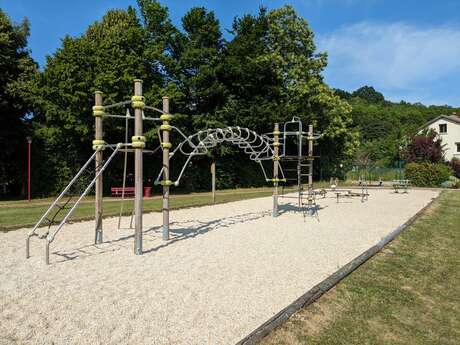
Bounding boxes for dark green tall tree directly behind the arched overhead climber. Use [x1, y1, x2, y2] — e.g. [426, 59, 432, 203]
[216, 8, 281, 132]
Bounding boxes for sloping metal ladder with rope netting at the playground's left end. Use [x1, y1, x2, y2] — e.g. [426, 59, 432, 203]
[26, 143, 123, 265]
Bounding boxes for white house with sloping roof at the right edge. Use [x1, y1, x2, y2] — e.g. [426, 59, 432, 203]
[421, 113, 460, 161]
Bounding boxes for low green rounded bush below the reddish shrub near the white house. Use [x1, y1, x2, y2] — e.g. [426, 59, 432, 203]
[405, 163, 451, 187]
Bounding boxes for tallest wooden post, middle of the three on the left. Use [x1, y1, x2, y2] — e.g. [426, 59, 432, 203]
[132, 79, 145, 255]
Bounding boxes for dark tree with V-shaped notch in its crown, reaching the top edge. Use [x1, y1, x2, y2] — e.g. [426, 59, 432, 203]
[138, 0, 224, 120]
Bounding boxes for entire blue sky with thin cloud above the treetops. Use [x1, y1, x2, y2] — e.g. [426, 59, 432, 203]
[0, 0, 460, 106]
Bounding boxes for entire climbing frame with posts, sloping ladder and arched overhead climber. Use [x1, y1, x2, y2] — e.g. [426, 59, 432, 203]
[26, 79, 328, 264]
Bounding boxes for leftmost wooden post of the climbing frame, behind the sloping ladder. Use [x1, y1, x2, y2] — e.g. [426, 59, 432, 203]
[94, 91, 104, 244]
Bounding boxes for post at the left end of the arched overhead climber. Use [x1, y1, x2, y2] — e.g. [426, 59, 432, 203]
[160, 96, 171, 241]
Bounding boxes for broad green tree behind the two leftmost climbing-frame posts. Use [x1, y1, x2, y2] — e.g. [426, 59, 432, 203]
[27, 8, 162, 193]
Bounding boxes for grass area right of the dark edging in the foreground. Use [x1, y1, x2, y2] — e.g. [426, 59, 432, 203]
[261, 192, 460, 345]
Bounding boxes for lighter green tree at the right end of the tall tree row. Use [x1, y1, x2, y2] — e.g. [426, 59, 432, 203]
[268, 6, 358, 169]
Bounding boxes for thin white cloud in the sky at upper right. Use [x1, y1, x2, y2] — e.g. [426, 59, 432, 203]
[318, 22, 460, 104]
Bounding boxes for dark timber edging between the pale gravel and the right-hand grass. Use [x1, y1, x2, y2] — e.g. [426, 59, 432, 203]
[236, 193, 441, 345]
